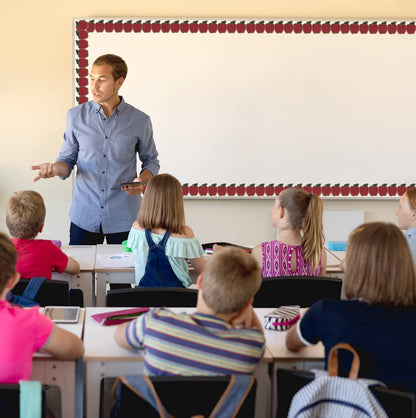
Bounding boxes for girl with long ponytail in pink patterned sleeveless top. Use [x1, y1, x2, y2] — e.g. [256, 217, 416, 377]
[252, 187, 326, 277]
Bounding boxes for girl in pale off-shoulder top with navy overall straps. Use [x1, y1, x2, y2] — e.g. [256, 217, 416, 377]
[127, 174, 205, 287]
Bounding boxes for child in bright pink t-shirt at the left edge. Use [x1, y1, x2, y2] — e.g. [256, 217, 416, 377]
[0, 233, 84, 383]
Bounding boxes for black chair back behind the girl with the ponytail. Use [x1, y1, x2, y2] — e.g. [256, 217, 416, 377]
[253, 276, 342, 308]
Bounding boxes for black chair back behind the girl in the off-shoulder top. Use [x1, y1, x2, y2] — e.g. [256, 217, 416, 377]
[107, 287, 198, 308]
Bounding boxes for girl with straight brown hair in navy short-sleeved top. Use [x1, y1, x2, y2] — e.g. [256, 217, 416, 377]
[286, 222, 416, 393]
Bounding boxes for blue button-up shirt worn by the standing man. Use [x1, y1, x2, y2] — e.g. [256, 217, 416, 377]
[57, 97, 159, 234]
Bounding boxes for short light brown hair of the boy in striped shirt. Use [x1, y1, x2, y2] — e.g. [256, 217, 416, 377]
[202, 247, 262, 314]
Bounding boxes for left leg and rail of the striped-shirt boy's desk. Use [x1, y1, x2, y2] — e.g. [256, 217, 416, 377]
[85, 361, 144, 418]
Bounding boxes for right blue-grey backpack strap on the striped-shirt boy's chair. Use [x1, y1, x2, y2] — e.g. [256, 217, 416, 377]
[210, 374, 255, 418]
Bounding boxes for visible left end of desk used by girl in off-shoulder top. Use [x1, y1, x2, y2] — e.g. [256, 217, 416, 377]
[95, 244, 135, 307]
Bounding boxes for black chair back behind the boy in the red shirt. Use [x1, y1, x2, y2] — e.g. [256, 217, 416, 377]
[12, 279, 69, 306]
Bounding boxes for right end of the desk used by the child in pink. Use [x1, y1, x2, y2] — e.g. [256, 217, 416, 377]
[30, 309, 86, 418]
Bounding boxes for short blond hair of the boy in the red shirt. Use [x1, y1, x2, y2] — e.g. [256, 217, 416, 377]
[6, 190, 46, 239]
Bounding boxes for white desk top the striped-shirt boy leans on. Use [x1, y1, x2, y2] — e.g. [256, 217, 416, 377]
[84, 308, 318, 362]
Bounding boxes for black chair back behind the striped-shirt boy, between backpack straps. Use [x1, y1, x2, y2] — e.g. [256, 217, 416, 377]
[100, 376, 257, 418]
